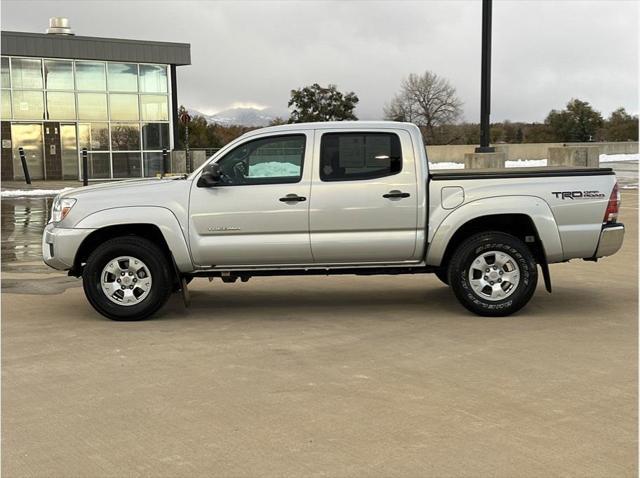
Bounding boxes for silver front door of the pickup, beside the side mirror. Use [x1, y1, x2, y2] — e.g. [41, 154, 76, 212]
[189, 132, 313, 266]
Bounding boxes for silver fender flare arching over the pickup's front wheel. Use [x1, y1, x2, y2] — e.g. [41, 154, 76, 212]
[75, 206, 193, 272]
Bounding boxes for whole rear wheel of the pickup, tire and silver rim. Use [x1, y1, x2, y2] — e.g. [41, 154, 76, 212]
[449, 232, 538, 317]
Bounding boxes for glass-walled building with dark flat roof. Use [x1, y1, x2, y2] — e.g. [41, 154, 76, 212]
[0, 20, 190, 180]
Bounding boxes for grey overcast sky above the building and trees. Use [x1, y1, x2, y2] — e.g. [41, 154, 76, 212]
[1, 0, 639, 121]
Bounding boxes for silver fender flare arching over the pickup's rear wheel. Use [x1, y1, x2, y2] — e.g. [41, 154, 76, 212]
[426, 196, 562, 266]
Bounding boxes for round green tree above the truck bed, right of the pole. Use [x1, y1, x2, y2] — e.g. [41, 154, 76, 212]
[545, 99, 603, 142]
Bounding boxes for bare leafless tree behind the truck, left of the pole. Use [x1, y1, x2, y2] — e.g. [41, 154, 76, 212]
[384, 71, 462, 140]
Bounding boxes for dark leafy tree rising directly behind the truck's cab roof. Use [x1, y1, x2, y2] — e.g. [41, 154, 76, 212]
[288, 83, 359, 123]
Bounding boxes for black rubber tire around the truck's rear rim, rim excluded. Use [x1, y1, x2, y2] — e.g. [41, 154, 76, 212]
[449, 233, 538, 316]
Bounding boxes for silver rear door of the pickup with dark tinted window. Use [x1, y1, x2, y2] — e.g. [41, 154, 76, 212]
[309, 129, 418, 264]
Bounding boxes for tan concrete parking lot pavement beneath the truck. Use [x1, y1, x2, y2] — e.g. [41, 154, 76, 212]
[2, 192, 638, 477]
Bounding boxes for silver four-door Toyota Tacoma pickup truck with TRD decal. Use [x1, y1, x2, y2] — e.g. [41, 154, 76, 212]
[42, 122, 624, 320]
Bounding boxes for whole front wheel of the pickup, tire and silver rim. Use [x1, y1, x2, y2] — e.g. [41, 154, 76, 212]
[82, 236, 173, 321]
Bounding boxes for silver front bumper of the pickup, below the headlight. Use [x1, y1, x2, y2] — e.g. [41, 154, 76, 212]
[42, 223, 95, 271]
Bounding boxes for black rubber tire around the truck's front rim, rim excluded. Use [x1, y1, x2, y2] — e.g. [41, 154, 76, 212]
[82, 237, 172, 320]
